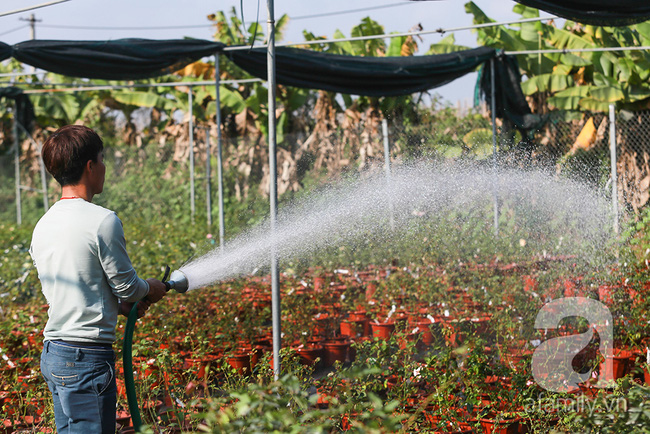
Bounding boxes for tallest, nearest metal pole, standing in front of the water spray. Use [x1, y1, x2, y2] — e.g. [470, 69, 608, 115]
[266, 0, 282, 380]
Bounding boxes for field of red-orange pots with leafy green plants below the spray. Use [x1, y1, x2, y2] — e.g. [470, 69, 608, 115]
[0, 215, 650, 433]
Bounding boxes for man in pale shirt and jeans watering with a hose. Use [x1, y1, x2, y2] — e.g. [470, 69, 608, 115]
[30, 125, 166, 434]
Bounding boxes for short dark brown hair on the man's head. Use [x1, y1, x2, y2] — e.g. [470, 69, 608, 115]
[42, 125, 104, 187]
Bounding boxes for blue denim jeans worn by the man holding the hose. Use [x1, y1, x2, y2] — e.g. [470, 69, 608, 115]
[41, 341, 117, 434]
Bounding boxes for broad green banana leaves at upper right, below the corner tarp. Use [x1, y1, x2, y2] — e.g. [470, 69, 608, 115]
[465, 2, 650, 112]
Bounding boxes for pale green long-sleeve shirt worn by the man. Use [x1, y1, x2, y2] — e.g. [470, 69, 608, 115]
[30, 199, 149, 343]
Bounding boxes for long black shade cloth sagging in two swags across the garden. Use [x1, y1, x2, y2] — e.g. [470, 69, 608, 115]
[0, 39, 530, 134]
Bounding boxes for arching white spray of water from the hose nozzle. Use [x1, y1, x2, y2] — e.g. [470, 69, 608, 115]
[181, 160, 612, 289]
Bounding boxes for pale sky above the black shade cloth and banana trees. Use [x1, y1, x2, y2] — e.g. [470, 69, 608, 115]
[0, 0, 528, 105]
